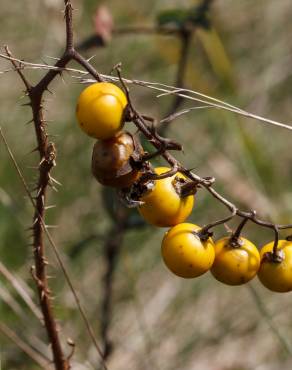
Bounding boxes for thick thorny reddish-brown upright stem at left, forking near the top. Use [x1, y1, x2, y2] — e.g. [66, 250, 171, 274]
[5, 0, 106, 370]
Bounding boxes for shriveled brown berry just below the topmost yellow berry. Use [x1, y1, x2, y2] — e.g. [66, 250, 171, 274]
[91, 131, 142, 188]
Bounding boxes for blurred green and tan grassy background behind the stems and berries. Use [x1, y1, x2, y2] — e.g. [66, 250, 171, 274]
[0, 0, 292, 370]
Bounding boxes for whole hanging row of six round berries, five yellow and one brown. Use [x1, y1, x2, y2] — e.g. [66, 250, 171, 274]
[76, 82, 292, 292]
